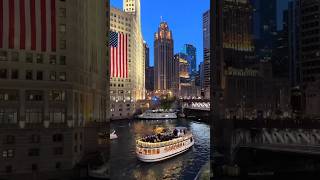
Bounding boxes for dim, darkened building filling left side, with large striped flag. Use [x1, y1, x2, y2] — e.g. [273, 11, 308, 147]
[0, 0, 109, 179]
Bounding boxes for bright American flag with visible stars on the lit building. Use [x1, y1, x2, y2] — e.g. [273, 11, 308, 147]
[109, 31, 128, 78]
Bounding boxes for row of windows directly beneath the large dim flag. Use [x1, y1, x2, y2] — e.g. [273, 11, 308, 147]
[0, 51, 66, 65]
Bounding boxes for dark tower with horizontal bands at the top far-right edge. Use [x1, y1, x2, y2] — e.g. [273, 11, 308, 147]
[300, 0, 320, 85]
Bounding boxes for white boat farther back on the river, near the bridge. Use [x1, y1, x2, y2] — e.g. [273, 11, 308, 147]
[138, 110, 178, 119]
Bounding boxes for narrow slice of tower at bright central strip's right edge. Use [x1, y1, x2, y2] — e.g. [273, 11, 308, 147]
[201, 10, 210, 99]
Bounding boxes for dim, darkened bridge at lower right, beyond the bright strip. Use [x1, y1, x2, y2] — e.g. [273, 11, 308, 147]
[218, 119, 320, 163]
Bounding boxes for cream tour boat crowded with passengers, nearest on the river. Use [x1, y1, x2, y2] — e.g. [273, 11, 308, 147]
[136, 127, 194, 162]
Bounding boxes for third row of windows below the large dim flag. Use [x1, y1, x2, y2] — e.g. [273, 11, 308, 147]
[0, 90, 66, 101]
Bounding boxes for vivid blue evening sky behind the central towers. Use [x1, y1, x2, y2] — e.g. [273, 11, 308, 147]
[110, 0, 210, 68]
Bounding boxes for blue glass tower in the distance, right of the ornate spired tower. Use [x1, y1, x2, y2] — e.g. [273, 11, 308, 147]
[182, 44, 197, 78]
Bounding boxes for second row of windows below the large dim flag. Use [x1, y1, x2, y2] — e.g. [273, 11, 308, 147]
[0, 68, 67, 81]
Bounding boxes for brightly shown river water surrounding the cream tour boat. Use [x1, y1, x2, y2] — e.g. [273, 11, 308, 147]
[110, 119, 210, 180]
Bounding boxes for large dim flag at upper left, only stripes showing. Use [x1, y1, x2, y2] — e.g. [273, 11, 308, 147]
[0, 0, 57, 51]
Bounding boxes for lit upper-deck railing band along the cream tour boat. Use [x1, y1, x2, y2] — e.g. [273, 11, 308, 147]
[136, 133, 192, 148]
